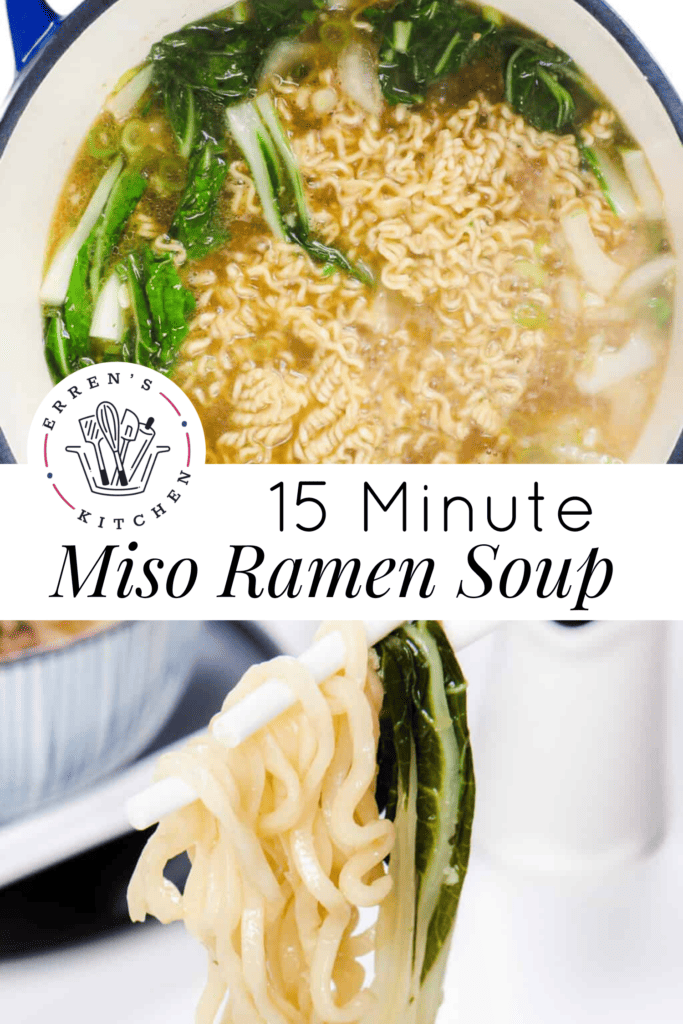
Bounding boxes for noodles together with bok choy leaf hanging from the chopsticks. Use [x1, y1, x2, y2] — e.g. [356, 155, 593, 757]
[128, 624, 474, 1024]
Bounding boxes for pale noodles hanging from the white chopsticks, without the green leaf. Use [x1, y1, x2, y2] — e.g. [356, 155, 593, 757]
[128, 623, 394, 1024]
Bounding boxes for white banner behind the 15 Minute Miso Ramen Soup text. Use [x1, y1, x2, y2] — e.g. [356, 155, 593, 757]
[0, 466, 683, 620]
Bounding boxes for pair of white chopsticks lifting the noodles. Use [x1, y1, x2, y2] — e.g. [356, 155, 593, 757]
[126, 620, 499, 830]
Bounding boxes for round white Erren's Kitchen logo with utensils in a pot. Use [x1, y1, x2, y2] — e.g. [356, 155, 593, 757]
[29, 362, 206, 530]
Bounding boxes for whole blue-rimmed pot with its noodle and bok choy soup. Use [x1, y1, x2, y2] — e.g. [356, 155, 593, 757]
[0, 0, 683, 464]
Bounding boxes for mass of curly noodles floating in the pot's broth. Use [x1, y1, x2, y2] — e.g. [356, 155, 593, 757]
[176, 69, 638, 463]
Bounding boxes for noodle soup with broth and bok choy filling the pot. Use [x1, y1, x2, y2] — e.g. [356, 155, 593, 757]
[43, 0, 675, 463]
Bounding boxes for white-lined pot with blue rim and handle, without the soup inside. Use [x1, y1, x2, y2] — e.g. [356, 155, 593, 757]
[0, 0, 683, 463]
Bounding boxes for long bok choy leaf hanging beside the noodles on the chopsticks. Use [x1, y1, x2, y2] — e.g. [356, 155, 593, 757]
[376, 623, 475, 1024]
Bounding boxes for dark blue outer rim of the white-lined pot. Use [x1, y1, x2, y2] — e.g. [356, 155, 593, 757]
[0, 0, 683, 464]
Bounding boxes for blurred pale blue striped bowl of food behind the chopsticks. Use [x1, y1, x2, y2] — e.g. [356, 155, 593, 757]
[0, 622, 201, 822]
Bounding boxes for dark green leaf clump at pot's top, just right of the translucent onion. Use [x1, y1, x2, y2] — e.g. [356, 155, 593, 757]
[365, 0, 497, 103]
